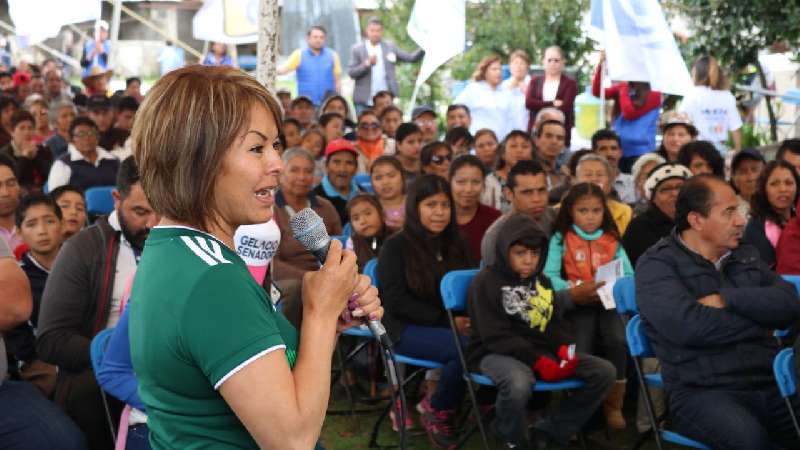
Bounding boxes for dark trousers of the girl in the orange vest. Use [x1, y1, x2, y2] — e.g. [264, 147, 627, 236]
[567, 306, 628, 381]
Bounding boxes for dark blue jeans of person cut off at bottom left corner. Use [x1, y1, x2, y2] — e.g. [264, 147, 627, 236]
[0, 380, 87, 450]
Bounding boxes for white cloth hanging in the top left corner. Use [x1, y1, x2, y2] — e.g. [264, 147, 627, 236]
[8, 0, 101, 44]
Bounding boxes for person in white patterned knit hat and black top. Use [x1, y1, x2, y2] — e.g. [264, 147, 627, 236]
[622, 162, 692, 266]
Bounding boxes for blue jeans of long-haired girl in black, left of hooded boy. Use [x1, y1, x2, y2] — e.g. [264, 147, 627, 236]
[394, 325, 466, 410]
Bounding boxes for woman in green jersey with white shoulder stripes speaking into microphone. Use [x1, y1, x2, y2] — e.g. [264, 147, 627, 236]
[130, 66, 383, 449]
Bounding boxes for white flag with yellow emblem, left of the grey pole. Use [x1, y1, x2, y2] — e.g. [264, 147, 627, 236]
[192, 0, 259, 44]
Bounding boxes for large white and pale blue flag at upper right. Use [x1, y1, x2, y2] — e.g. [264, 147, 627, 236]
[590, 0, 693, 95]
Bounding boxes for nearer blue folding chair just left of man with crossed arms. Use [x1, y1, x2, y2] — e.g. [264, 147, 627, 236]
[625, 314, 710, 450]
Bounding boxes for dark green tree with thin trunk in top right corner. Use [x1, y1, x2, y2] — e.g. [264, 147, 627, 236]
[676, 0, 800, 141]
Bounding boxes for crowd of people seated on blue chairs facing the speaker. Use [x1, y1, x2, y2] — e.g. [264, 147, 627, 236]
[0, 47, 800, 449]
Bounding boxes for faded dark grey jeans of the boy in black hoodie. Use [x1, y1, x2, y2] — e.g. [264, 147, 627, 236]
[480, 353, 616, 445]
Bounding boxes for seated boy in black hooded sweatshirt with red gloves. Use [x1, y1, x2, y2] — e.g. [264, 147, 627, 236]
[468, 214, 616, 448]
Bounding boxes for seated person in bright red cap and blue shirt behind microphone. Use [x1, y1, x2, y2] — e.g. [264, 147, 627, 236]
[314, 138, 364, 224]
